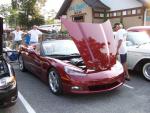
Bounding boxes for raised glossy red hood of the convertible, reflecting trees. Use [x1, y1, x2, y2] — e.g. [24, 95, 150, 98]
[61, 18, 117, 71]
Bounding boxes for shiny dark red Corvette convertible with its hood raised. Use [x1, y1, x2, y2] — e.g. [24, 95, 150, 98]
[19, 20, 124, 95]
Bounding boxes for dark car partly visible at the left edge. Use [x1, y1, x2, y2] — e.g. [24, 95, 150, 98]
[0, 57, 18, 107]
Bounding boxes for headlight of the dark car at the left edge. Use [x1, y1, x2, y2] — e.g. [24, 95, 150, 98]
[0, 76, 16, 89]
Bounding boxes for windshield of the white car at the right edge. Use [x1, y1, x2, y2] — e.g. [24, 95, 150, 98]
[127, 32, 150, 45]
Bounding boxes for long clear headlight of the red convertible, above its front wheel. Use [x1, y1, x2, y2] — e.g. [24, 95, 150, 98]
[65, 66, 86, 76]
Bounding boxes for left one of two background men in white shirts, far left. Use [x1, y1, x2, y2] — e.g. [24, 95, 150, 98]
[10, 26, 24, 49]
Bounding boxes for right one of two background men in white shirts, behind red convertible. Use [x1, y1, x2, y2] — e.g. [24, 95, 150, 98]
[28, 25, 42, 44]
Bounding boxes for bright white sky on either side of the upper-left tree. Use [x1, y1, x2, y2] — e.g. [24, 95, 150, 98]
[0, 0, 64, 11]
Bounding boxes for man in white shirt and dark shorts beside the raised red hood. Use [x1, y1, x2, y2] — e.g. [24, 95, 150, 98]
[114, 23, 130, 80]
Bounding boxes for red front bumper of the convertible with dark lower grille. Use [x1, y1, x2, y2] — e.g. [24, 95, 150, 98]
[63, 73, 125, 94]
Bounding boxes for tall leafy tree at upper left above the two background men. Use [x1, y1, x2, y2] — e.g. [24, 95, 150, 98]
[12, 0, 46, 28]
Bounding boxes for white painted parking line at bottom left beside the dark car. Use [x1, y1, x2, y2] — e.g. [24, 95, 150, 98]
[18, 91, 36, 113]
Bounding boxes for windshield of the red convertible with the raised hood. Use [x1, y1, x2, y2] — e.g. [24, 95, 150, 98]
[43, 40, 79, 56]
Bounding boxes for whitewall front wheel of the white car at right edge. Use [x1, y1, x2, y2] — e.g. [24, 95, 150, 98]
[143, 63, 150, 80]
